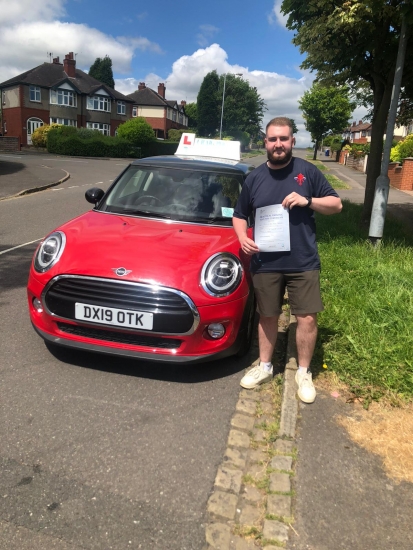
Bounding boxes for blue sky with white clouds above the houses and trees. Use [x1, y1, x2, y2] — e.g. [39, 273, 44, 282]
[0, 0, 365, 147]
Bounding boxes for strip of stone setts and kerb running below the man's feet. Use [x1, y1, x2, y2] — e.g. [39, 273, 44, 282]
[203, 315, 298, 550]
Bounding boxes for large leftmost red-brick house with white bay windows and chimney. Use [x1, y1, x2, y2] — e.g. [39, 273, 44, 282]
[0, 52, 133, 145]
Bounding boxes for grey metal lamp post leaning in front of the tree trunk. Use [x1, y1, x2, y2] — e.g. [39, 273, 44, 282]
[369, 17, 407, 244]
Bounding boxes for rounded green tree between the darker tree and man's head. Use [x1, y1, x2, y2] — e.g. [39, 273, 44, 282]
[218, 74, 266, 137]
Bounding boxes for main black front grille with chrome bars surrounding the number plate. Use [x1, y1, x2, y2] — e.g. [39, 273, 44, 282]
[44, 275, 198, 334]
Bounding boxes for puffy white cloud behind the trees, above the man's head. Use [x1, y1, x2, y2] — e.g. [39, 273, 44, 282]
[116, 44, 314, 147]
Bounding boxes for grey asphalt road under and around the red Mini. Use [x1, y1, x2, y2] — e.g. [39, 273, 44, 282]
[0, 156, 256, 550]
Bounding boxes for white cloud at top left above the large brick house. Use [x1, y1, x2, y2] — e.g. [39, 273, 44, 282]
[0, 0, 162, 82]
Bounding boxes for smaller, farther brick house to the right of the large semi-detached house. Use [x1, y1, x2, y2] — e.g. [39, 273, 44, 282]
[126, 82, 188, 139]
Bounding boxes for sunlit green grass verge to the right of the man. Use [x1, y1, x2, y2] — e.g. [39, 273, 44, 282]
[313, 201, 413, 403]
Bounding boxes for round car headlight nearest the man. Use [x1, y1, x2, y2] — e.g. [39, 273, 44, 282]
[201, 252, 242, 296]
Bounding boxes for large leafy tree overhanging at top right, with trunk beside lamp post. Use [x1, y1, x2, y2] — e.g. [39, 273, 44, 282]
[281, 0, 413, 222]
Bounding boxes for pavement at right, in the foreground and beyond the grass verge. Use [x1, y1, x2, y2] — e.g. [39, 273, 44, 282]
[286, 159, 413, 550]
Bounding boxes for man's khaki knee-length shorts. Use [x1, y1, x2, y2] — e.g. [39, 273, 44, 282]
[252, 270, 324, 317]
